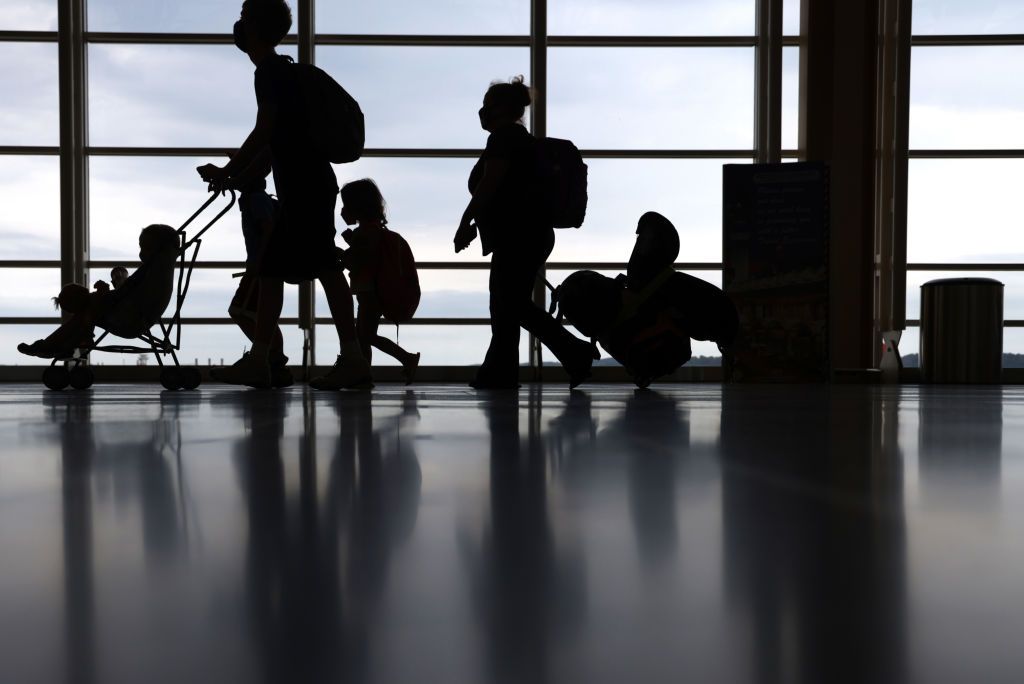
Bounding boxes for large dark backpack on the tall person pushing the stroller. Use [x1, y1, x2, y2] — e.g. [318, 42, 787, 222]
[293, 63, 367, 164]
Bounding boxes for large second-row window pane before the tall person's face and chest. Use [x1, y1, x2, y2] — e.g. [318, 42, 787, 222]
[89, 45, 295, 148]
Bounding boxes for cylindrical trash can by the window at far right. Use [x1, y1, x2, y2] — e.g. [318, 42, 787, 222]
[921, 277, 1002, 383]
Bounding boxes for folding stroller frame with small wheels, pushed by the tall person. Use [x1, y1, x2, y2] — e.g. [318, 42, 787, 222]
[43, 190, 234, 390]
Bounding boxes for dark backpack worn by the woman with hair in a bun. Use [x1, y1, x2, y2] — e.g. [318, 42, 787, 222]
[538, 138, 587, 228]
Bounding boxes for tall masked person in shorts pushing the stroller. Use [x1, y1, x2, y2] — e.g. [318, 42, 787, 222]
[198, 0, 370, 389]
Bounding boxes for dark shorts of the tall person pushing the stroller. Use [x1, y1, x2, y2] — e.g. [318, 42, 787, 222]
[256, 189, 341, 284]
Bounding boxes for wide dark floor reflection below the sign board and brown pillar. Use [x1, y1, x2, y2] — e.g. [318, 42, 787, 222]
[721, 388, 908, 684]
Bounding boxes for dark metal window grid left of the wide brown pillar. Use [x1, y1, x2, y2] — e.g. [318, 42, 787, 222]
[0, 0, 799, 369]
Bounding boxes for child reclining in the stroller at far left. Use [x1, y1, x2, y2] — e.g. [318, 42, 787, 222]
[17, 223, 180, 358]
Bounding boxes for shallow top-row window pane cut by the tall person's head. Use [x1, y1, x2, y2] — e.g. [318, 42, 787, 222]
[86, 0, 296, 35]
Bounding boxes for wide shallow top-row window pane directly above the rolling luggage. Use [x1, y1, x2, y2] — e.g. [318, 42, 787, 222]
[548, 0, 756, 36]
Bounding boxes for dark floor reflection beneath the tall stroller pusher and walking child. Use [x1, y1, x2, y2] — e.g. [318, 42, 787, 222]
[233, 392, 421, 682]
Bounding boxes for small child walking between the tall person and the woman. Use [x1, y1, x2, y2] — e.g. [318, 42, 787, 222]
[341, 178, 420, 384]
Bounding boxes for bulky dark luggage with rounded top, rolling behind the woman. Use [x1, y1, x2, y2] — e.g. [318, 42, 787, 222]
[555, 212, 739, 387]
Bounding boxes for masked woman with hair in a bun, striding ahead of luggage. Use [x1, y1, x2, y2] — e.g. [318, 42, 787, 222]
[455, 77, 595, 389]
